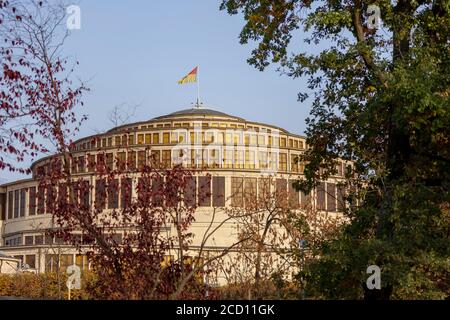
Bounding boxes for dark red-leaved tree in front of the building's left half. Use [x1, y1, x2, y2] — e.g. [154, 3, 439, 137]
[45, 158, 253, 300]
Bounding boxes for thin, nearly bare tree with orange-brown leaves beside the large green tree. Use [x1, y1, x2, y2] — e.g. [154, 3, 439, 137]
[217, 176, 342, 299]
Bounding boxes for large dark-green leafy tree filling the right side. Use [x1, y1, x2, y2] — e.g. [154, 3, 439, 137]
[221, 0, 450, 298]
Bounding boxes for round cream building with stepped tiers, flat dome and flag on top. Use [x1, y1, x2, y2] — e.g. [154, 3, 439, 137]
[0, 107, 346, 272]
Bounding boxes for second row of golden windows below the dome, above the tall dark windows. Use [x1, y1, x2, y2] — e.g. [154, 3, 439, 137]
[35, 149, 310, 177]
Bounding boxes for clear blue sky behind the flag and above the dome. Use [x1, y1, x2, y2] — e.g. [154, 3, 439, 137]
[0, 0, 309, 181]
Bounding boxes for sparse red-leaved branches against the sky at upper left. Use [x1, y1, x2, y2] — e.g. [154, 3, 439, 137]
[0, 0, 88, 173]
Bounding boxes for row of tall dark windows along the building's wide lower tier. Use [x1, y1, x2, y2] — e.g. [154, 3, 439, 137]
[7, 176, 344, 220]
